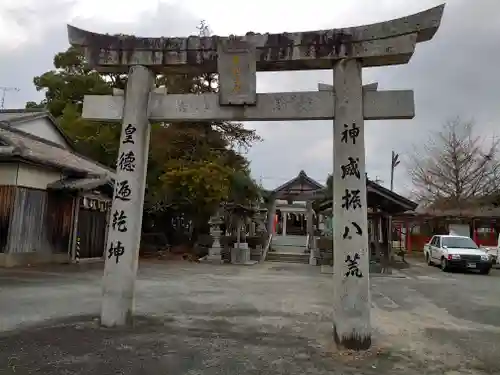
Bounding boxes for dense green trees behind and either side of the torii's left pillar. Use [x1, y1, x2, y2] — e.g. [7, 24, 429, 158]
[26, 25, 259, 244]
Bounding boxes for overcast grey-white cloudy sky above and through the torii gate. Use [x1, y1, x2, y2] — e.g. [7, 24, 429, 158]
[0, 0, 500, 195]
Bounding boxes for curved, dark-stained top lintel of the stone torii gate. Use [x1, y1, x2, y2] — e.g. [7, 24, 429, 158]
[68, 5, 444, 73]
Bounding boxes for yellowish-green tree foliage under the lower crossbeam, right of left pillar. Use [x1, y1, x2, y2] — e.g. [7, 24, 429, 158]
[146, 124, 260, 241]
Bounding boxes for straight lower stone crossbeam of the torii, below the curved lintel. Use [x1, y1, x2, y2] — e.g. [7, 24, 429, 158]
[83, 90, 415, 122]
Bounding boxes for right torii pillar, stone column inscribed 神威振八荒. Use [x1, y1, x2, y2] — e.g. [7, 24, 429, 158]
[332, 8, 442, 350]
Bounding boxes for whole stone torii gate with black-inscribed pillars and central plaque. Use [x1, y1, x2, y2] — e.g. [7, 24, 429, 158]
[68, 5, 444, 349]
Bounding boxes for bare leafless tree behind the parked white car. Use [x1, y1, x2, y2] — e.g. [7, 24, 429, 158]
[408, 118, 500, 208]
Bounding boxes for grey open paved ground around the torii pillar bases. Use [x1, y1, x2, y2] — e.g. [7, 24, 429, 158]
[0, 261, 500, 375]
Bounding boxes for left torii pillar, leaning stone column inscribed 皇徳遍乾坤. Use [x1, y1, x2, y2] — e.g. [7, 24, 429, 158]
[101, 66, 155, 327]
